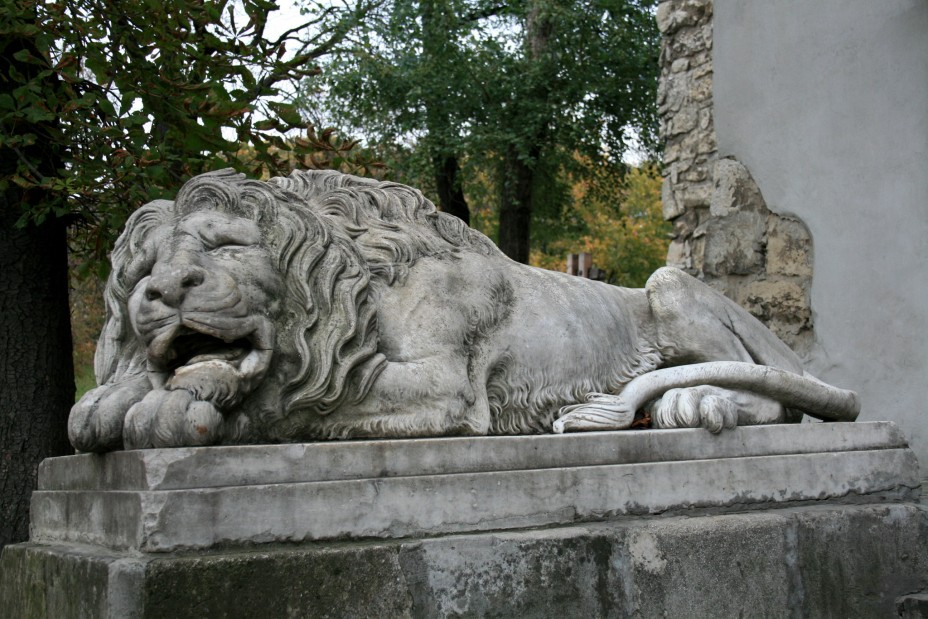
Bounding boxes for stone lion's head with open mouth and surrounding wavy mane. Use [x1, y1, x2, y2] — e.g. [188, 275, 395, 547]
[91, 171, 384, 448]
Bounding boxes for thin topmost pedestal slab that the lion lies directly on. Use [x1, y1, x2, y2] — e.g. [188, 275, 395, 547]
[38, 421, 908, 490]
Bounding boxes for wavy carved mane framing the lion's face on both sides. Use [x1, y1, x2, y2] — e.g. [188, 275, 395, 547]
[95, 170, 384, 432]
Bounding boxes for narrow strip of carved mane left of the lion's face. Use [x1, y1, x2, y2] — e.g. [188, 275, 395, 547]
[93, 200, 174, 385]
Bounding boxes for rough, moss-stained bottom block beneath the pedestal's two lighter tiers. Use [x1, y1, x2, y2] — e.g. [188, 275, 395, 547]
[0, 503, 928, 619]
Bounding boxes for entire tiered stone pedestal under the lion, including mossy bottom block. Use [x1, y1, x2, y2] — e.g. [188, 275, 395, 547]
[0, 423, 928, 617]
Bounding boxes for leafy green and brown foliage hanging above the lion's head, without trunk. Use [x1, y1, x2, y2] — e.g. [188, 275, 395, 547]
[0, 0, 376, 272]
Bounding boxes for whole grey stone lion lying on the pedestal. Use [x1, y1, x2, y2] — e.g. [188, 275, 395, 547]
[68, 170, 859, 452]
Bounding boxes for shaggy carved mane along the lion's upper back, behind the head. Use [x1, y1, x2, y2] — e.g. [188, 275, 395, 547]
[269, 170, 503, 285]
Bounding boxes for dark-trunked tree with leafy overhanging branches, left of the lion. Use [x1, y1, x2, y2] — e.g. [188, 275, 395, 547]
[0, 0, 374, 546]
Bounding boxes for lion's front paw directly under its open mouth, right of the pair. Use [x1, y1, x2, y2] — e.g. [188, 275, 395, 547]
[123, 389, 223, 449]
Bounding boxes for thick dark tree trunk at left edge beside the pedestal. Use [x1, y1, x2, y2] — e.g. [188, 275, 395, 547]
[0, 20, 74, 548]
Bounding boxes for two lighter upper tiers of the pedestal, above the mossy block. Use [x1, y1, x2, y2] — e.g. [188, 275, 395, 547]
[31, 423, 918, 552]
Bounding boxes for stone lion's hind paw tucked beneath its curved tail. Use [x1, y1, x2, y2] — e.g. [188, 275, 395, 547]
[651, 387, 738, 434]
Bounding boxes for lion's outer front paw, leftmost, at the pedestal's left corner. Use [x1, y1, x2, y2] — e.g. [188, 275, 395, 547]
[68, 376, 151, 452]
